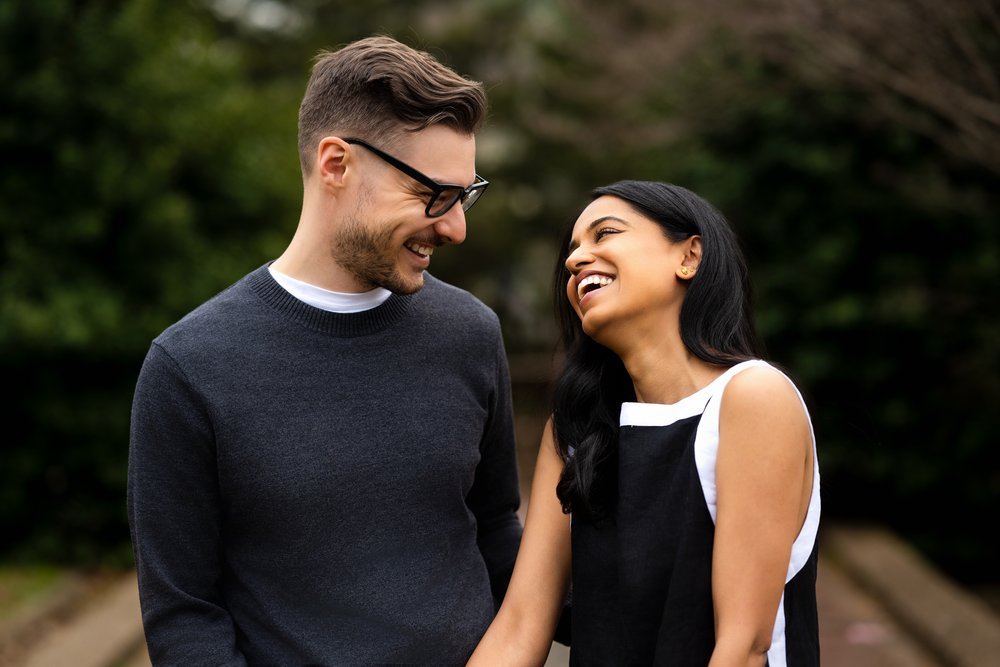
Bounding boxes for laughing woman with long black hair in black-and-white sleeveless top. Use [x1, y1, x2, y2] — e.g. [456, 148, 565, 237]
[469, 181, 820, 667]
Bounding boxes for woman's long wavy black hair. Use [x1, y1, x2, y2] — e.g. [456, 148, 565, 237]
[552, 181, 763, 521]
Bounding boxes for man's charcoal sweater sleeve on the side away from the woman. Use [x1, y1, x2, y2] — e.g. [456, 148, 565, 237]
[127, 343, 246, 666]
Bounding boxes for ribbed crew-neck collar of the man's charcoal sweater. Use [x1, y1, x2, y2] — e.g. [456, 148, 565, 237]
[246, 264, 414, 338]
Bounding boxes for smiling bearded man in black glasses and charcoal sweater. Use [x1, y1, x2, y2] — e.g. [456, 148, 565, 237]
[128, 37, 521, 665]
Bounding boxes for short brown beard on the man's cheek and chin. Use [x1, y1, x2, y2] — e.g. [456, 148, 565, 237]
[334, 216, 426, 294]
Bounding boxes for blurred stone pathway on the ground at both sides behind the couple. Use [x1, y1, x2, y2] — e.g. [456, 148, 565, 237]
[7, 527, 1000, 667]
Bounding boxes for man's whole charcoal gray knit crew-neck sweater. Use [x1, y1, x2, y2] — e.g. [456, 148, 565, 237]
[128, 266, 521, 666]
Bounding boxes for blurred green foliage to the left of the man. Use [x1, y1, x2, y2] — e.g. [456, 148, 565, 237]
[0, 0, 299, 560]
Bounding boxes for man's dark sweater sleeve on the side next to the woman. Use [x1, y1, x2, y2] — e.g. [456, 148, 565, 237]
[467, 331, 521, 606]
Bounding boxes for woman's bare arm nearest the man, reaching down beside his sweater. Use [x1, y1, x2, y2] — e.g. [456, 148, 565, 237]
[468, 420, 570, 667]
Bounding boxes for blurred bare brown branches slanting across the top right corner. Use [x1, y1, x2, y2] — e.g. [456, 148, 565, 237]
[708, 0, 1000, 174]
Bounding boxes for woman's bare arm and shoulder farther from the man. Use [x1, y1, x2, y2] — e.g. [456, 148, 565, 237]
[709, 368, 813, 667]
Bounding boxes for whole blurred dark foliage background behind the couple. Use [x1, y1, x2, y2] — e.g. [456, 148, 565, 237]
[0, 0, 1000, 584]
